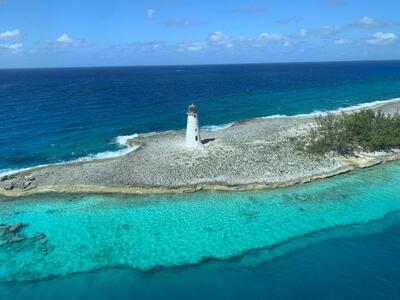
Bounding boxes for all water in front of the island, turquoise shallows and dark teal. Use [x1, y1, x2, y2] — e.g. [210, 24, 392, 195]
[0, 162, 400, 300]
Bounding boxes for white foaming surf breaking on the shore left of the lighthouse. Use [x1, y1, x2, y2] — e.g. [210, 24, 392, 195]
[0, 134, 139, 177]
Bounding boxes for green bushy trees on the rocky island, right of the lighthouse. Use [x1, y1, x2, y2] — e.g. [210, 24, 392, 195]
[298, 109, 400, 154]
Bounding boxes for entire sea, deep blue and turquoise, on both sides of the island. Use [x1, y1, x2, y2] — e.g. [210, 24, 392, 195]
[0, 62, 400, 300]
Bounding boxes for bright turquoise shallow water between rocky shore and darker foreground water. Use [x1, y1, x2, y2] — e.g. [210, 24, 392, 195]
[0, 162, 400, 283]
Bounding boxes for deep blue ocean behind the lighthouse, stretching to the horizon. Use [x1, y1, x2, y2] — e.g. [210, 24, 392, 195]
[0, 61, 400, 173]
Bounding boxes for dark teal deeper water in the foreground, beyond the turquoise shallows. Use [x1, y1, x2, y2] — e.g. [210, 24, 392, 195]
[0, 214, 400, 300]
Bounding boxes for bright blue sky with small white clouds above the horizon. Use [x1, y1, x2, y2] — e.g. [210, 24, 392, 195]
[0, 0, 400, 68]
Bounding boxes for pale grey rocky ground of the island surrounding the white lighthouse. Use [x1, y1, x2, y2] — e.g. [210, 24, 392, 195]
[0, 99, 400, 197]
